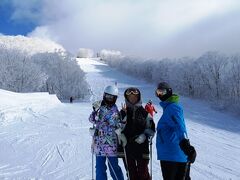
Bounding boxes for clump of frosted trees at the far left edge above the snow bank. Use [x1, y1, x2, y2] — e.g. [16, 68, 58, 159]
[0, 46, 46, 92]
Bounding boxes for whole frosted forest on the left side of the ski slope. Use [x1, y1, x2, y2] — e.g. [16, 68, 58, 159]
[0, 38, 89, 100]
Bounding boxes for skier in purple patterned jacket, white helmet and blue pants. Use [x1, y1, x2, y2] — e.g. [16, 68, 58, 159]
[89, 86, 124, 180]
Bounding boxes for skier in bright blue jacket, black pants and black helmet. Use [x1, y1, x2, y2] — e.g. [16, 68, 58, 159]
[155, 82, 190, 180]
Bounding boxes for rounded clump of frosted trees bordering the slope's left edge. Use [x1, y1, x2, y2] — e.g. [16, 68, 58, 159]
[32, 53, 88, 99]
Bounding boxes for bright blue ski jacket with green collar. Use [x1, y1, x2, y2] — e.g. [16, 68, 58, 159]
[156, 94, 187, 162]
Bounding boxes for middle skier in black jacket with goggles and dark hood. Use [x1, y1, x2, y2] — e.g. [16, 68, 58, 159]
[116, 87, 155, 180]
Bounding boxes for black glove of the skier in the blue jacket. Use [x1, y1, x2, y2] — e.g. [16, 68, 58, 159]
[179, 138, 197, 163]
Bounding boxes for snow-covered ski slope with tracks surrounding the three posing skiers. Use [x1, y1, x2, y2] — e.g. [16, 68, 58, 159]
[0, 59, 240, 180]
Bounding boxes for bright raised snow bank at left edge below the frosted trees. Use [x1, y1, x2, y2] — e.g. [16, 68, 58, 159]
[0, 89, 61, 126]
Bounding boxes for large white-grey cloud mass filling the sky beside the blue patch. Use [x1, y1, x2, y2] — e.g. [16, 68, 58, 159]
[5, 0, 240, 57]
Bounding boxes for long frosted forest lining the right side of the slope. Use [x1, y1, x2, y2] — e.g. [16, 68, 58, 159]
[103, 52, 240, 113]
